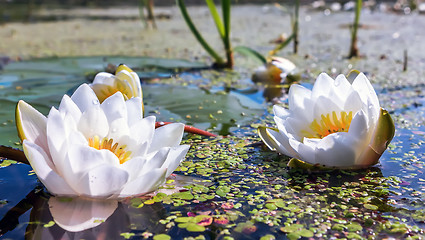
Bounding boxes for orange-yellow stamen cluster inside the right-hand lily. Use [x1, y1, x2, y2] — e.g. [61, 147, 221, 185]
[301, 111, 353, 138]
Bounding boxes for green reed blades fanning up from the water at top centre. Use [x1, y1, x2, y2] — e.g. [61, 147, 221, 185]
[176, 0, 233, 68]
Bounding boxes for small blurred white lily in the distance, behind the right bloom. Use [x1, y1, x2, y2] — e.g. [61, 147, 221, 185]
[252, 57, 296, 84]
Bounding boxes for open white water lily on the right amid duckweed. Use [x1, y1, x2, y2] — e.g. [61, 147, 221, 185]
[259, 73, 395, 168]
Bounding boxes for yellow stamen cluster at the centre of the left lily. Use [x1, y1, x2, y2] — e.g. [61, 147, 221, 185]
[89, 136, 131, 164]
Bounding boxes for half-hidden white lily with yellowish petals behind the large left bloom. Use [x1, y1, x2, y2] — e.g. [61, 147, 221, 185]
[89, 64, 143, 102]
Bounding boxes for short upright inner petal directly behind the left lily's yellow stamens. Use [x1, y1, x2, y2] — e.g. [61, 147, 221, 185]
[78, 106, 109, 139]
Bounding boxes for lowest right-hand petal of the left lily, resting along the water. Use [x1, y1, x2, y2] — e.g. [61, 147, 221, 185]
[119, 168, 167, 198]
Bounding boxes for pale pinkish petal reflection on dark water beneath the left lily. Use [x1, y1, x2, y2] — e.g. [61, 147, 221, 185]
[48, 197, 118, 232]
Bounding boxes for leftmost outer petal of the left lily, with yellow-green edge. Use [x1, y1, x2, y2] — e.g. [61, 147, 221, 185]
[16, 100, 49, 153]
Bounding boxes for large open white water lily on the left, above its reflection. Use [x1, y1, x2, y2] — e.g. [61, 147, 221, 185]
[16, 84, 189, 199]
